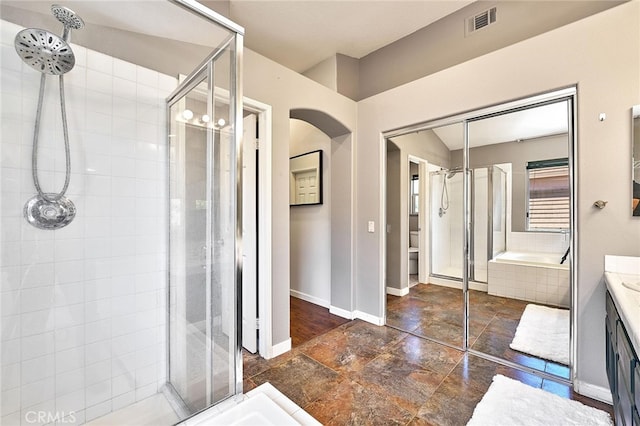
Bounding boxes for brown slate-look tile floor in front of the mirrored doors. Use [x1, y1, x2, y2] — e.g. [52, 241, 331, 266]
[244, 296, 611, 425]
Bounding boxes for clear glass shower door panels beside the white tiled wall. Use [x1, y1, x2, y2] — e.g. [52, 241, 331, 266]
[167, 22, 242, 415]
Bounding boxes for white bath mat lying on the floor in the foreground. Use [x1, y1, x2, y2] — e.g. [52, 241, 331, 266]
[467, 374, 612, 426]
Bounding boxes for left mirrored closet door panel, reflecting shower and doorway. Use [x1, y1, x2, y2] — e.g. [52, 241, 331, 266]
[386, 121, 464, 348]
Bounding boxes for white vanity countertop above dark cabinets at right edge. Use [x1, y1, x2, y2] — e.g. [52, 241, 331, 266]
[604, 255, 640, 351]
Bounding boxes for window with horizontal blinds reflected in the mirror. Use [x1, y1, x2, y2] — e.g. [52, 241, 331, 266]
[527, 158, 571, 231]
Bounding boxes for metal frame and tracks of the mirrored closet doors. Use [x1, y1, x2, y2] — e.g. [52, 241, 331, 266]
[379, 85, 579, 384]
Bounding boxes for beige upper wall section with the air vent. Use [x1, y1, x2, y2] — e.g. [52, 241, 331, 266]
[354, 0, 618, 100]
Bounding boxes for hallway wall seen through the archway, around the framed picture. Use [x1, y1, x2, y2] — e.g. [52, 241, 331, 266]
[289, 119, 331, 308]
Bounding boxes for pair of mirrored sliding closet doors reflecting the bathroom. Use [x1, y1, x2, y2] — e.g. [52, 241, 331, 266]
[386, 89, 575, 381]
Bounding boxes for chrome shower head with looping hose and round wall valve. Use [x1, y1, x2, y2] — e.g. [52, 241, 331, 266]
[14, 4, 84, 229]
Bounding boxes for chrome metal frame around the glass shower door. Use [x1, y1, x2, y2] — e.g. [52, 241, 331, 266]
[164, 0, 244, 421]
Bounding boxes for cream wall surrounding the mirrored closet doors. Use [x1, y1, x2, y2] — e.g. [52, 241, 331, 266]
[356, 1, 640, 393]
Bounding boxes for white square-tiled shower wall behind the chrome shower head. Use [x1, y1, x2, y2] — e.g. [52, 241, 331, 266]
[0, 21, 176, 425]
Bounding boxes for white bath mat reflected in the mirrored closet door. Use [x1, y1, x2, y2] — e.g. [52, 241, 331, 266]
[509, 304, 569, 365]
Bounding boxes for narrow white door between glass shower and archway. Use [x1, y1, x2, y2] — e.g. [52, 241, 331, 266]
[242, 114, 258, 353]
